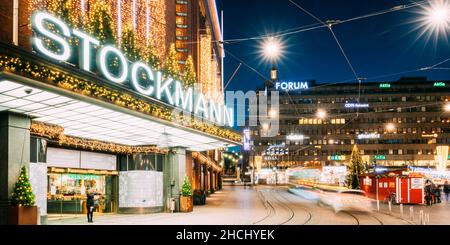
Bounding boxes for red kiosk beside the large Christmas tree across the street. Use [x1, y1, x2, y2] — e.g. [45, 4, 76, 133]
[360, 172, 425, 204]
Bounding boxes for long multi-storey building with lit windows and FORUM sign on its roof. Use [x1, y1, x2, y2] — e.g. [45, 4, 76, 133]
[251, 77, 450, 167]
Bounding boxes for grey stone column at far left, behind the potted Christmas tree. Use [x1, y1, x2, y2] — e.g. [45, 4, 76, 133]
[0, 112, 31, 224]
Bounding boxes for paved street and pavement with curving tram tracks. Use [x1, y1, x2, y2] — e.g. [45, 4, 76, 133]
[44, 186, 444, 225]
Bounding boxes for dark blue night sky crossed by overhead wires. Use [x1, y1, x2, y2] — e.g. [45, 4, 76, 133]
[217, 0, 450, 90]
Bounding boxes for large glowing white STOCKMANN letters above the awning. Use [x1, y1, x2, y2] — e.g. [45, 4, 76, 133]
[32, 12, 234, 127]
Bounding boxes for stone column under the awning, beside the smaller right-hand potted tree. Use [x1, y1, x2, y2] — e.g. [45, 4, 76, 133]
[164, 147, 186, 211]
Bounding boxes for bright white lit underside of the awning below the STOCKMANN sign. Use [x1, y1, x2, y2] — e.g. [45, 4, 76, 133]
[0, 79, 235, 151]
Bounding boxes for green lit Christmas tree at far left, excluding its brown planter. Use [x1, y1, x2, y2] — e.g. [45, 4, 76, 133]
[11, 167, 34, 207]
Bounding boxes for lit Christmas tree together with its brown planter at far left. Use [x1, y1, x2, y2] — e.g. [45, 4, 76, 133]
[9, 167, 38, 225]
